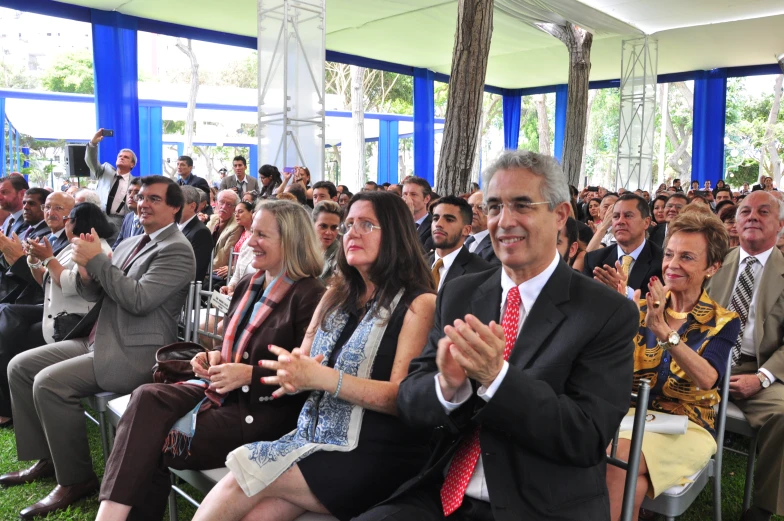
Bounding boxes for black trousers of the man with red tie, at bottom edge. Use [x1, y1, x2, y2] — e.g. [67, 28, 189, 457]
[353, 482, 493, 521]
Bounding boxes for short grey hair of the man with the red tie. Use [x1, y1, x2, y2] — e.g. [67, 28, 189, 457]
[482, 150, 571, 211]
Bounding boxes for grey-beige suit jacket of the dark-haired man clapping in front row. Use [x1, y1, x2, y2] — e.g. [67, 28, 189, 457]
[76, 225, 196, 392]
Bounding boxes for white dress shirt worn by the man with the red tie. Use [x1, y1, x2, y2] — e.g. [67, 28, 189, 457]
[435, 251, 561, 501]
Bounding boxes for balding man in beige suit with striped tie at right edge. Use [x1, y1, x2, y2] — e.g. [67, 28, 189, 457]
[708, 191, 784, 521]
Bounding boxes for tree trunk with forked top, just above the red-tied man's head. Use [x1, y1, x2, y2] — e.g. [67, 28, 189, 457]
[539, 23, 593, 186]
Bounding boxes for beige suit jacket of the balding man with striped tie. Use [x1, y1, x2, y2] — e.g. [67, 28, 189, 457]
[706, 248, 784, 380]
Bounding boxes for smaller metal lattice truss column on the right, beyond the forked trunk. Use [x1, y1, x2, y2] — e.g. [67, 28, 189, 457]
[616, 36, 659, 190]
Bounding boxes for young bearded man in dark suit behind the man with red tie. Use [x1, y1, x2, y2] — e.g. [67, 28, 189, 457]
[428, 195, 492, 291]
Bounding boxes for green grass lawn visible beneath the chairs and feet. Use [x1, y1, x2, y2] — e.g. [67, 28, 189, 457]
[0, 422, 784, 521]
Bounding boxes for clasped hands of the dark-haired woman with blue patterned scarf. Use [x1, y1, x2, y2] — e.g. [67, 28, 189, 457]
[259, 346, 325, 398]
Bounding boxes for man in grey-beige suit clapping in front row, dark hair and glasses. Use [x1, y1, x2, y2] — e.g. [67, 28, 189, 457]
[0, 176, 196, 519]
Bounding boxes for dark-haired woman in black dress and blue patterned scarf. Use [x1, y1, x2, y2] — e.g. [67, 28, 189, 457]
[194, 192, 435, 521]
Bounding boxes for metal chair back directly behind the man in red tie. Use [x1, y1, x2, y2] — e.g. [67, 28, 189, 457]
[607, 379, 651, 521]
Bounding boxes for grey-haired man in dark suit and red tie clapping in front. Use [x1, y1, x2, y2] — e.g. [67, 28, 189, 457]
[359, 150, 639, 521]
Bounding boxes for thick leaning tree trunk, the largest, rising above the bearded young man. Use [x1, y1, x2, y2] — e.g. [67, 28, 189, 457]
[436, 0, 494, 195]
